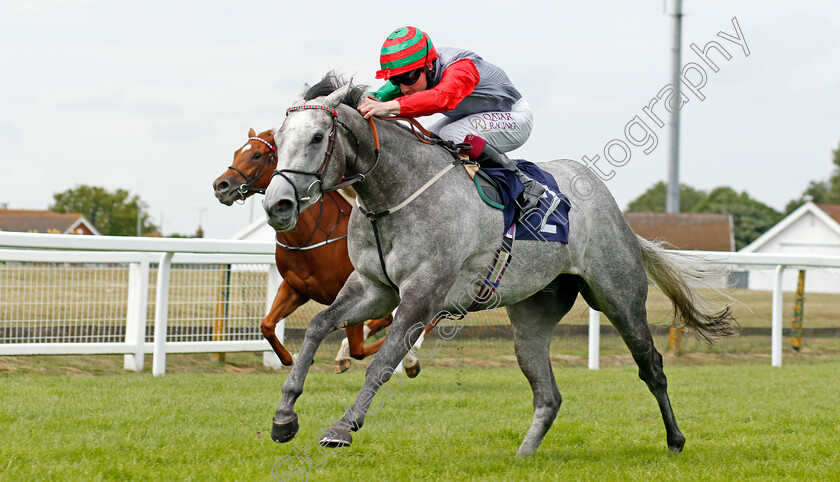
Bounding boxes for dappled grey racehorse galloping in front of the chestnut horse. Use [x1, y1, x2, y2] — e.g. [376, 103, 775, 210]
[263, 76, 735, 456]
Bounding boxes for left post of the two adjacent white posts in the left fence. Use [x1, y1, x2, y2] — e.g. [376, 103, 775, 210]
[123, 260, 149, 372]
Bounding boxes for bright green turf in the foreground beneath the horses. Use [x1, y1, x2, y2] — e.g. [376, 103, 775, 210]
[0, 352, 840, 480]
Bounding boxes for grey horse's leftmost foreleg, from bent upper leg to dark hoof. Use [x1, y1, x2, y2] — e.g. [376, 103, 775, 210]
[271, 272, 399, 442]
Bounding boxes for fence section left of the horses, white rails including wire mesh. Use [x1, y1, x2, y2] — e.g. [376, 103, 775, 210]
[0, 233, 276, 375]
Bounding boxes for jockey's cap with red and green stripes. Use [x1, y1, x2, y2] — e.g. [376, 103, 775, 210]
[376, 27, 437, 80]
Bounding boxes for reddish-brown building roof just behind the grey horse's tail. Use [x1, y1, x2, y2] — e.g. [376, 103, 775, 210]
[624, 213, 735, 251]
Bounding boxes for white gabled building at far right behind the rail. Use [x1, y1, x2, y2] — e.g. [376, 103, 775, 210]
[741, 201, 840, 293]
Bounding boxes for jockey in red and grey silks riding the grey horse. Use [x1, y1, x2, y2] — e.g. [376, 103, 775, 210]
[358, 27, 545, 213]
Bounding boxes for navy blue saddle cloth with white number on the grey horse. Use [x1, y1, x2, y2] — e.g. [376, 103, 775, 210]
[481, 159, 572, 243]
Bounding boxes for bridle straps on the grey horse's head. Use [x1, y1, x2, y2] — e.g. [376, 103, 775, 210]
[272, 104, 379, 211]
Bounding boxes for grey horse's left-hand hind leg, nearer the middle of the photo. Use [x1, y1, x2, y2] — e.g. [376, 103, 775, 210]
[507, 277, 577, 456]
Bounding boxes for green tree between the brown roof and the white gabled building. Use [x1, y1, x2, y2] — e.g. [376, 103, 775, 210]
[694, 187, 783, 250]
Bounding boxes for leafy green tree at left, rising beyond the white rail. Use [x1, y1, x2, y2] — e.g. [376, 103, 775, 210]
[49, 184, 157, 236]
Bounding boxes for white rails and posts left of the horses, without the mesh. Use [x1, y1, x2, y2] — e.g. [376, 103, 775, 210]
[0, 232, 283, 376]
